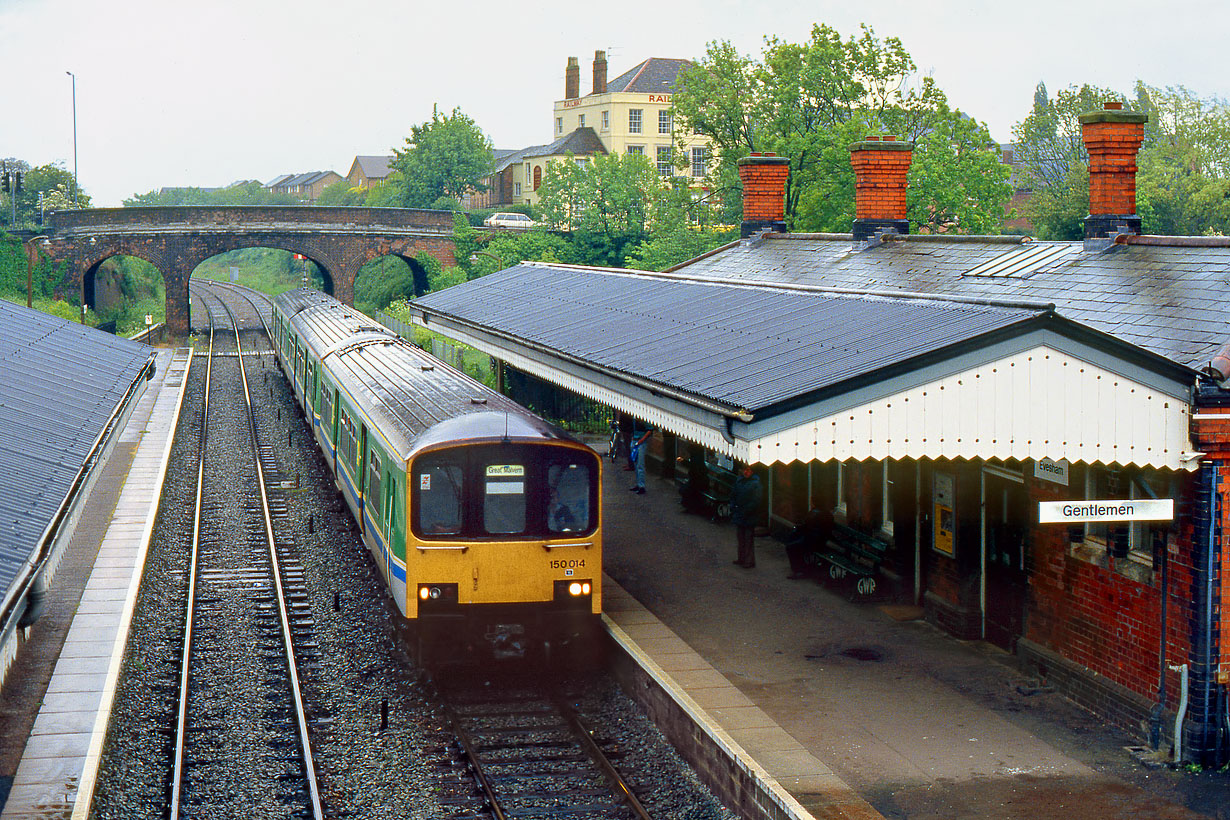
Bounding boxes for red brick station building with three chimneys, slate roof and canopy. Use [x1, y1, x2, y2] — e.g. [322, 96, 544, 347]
[412, 106, 1230, 765]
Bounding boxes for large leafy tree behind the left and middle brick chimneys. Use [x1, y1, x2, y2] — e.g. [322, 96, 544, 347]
[673, 25, 1011, 232]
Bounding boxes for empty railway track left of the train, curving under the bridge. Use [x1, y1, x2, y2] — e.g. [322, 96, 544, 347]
[169, 285, 327, 819]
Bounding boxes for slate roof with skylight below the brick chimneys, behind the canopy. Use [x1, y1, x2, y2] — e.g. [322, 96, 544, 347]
[675, 234, 1230, 370]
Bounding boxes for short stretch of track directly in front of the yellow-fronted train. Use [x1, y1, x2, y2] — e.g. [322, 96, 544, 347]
[429, 677, 651, 820]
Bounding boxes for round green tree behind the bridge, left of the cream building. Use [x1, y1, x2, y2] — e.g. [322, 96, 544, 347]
[385, 108, 493, 208]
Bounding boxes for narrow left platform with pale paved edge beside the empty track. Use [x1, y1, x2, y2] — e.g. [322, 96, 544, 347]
[0, 349, 191, 820]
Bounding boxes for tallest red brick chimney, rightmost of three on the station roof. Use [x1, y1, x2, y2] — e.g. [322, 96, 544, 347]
[1077, 102, 1149, 240]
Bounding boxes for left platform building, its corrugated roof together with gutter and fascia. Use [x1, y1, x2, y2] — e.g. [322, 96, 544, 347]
[0, 300, 154, 682]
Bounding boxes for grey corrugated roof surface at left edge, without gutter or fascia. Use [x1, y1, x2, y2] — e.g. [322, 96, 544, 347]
[0, 300, 151, 589]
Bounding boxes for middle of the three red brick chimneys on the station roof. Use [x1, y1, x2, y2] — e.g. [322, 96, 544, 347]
[850, 135, 914, 243]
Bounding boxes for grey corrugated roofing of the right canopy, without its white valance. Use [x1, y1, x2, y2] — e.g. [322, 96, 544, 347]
[412, 262, 1102, 417]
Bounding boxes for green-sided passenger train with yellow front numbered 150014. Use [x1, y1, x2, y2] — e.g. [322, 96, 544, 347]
[272, 289, 603, 658]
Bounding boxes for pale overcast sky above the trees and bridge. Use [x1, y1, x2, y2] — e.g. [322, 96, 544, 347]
[0, 0, 1230, 205]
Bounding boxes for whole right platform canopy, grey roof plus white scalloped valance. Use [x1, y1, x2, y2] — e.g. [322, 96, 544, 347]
[411, 263, 1194, 468]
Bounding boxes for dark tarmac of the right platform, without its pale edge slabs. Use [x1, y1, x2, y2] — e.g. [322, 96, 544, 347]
[604, 461, 1230, 820]
